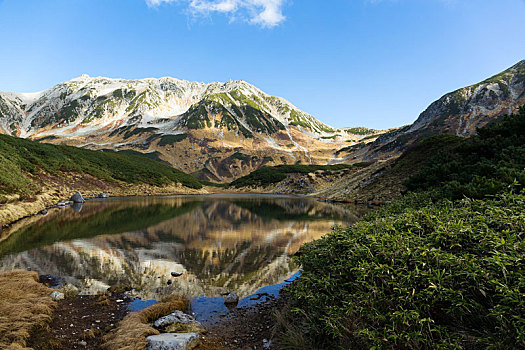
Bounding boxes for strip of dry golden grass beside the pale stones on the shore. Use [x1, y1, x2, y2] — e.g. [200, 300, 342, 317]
[102, 296, 189, 350]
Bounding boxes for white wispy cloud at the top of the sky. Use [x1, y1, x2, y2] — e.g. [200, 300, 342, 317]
[146, 0, 286, 28]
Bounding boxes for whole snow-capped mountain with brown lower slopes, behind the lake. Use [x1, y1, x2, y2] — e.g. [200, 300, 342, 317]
[0, 75, 376, 181]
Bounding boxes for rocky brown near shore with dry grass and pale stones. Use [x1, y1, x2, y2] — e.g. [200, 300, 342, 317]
[0, 271, 284, 350]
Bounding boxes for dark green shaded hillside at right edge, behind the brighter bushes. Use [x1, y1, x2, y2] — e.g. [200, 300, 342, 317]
[405, 107, 525, 199]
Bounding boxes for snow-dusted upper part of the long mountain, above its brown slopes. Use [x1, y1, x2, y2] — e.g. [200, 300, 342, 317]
[0, 75, 335, 137]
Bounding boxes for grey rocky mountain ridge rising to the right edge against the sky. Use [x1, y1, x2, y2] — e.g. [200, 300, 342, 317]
[336, 60, 525, 161]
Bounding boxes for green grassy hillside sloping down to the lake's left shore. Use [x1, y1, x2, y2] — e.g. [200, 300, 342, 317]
[0, 135, 202, 197]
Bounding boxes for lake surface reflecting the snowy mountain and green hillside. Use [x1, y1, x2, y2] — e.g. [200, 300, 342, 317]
[0, 195, 362, 298]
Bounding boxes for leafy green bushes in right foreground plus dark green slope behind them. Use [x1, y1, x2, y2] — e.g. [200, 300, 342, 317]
[281, 109, 525, 349]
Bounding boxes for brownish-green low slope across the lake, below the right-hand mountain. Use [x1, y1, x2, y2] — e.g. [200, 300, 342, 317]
[231, 134, 463, 204]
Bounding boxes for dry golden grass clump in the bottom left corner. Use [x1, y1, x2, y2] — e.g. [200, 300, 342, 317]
[0, 271, 56, 350]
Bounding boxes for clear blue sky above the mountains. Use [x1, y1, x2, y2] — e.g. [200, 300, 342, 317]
[0, 0, 525, 128]
